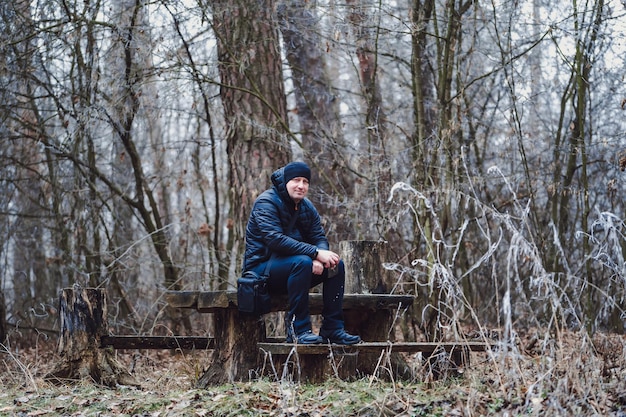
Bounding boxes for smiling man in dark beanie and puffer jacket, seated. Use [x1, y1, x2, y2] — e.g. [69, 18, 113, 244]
[243, 162, 361, 345]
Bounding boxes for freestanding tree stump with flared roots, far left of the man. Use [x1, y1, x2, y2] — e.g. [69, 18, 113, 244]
[45, 287, 139, 387]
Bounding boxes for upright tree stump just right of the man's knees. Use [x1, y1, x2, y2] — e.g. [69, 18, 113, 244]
[340, 240, 414, 379]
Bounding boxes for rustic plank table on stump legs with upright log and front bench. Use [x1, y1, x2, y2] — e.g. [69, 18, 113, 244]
[160, 241, 487, 387]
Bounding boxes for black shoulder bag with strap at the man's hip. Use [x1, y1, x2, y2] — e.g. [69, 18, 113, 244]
[237, 213, 297, 316]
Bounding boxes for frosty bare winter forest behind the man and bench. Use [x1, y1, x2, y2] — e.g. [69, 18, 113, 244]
[0, 0, 626, 348]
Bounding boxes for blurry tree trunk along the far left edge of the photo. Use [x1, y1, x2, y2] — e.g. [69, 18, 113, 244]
[2, 1, 69, 334]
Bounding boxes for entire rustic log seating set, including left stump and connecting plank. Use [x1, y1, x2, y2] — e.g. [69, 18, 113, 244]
[45, 237, 490, 387]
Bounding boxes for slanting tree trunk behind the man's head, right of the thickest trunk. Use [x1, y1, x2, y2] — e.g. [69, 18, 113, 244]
[278, 0, 355, 241]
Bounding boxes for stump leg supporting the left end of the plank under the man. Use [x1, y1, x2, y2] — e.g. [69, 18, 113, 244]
[196, 307, 265, 388]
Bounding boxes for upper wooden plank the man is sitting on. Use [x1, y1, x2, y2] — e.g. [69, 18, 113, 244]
[165, 290, 415, 314]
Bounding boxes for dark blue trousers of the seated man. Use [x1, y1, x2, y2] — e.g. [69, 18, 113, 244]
[255, 255, 346, 335]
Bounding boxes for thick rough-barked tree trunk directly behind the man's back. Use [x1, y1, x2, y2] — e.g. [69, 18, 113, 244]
[211, 0, 291, 264]
